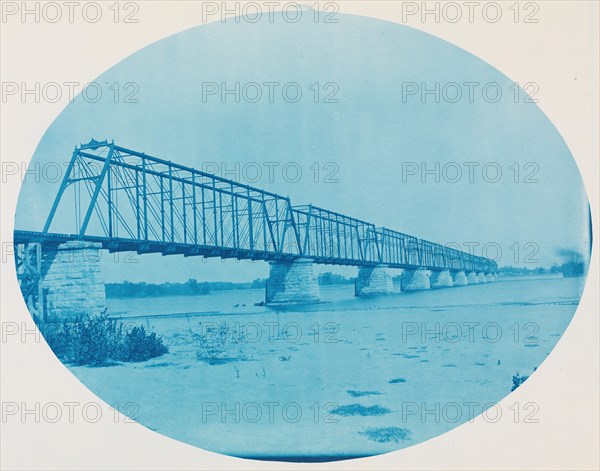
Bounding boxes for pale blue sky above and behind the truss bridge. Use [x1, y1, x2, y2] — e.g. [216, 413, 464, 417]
[16, 15, 589, 282]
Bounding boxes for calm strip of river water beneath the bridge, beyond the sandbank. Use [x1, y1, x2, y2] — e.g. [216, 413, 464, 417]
[107, 277, 585, 318]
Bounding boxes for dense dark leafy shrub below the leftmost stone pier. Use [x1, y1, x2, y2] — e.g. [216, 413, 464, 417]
[39, 310, 169, 366]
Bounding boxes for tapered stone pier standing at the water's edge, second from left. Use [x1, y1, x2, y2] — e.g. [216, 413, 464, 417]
[265, 258, 321, 304]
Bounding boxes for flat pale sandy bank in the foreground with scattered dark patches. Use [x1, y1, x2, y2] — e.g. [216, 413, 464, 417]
[71, 284, 576, 460]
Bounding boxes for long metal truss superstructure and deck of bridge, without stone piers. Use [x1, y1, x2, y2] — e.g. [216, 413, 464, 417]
[25, 140, 497, 273]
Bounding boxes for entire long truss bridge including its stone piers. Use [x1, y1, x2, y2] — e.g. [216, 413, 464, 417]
[14, 139, 498, 317]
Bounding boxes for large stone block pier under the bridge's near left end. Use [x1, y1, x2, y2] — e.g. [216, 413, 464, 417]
[42, 241, 106, 321]
